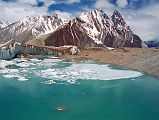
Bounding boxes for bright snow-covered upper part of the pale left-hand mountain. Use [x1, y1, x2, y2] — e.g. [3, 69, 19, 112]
[16, 14, 66, 36]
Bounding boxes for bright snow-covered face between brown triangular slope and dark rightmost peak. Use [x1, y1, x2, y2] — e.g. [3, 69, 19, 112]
[79, 10, 111, 44]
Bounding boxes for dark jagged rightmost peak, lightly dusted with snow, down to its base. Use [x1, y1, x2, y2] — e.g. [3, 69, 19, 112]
[111, 10, 142, 47]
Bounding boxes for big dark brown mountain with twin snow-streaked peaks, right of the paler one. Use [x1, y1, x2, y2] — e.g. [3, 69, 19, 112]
[45, 10, 142, 47]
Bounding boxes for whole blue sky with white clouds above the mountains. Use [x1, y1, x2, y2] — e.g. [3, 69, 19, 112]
[0, 0, 159, 40]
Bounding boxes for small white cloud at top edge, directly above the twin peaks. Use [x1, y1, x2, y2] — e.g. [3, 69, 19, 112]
[94, 0, 114, 9]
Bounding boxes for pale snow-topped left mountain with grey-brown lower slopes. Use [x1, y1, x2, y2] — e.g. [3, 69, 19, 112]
[0, 14, 66, 43]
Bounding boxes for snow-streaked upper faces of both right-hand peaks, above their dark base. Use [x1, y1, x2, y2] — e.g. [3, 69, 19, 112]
[79, 10, 137, 44]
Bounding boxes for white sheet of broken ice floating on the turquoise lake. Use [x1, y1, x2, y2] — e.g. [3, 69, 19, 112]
[0, 59, 142, 84]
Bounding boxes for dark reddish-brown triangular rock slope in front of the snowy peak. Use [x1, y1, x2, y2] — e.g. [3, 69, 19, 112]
[45, 19, 96, 47]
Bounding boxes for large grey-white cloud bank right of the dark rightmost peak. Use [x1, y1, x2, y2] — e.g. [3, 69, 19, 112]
[120, 4, 159, 41]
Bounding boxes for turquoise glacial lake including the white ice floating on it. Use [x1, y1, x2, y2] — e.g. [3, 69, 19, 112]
[0, 58, 159, 120]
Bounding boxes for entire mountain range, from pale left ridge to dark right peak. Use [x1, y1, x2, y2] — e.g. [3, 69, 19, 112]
[0, 10, 142, 47]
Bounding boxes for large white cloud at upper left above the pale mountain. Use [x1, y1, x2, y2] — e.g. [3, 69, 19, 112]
[0, 1, 47, 23]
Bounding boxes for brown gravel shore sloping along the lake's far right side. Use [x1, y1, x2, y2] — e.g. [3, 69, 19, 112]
[60, 47, 159, 77]
